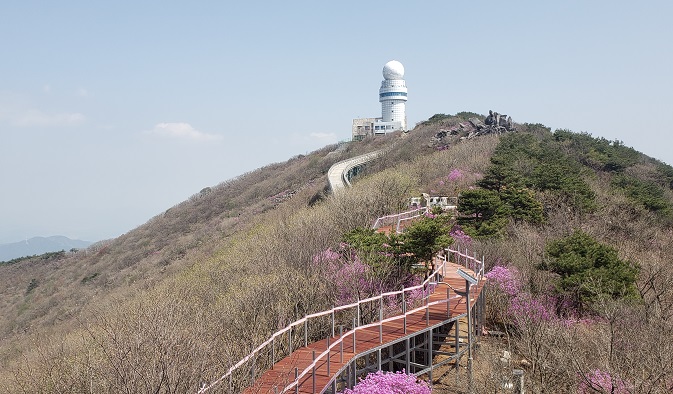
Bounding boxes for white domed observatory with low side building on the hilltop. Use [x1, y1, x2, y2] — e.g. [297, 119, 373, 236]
[353, 60, 407, 141]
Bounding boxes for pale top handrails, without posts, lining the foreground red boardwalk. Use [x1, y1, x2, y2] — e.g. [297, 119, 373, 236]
[198, 248, 484, 394]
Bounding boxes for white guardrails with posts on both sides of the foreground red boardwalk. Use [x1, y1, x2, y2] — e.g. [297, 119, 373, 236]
[198, 248, 484, 394]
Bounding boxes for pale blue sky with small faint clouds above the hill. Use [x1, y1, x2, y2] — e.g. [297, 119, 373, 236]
[0, 0, 673, 243]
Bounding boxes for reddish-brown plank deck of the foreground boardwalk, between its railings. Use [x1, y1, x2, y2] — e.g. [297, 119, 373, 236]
[243, 262, 485, 394]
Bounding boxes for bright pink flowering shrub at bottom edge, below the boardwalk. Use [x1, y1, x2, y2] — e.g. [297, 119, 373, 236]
[343, 370, 431, 394]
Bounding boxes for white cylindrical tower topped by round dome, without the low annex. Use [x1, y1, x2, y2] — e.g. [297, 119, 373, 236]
[379, 60, 407, 130]
